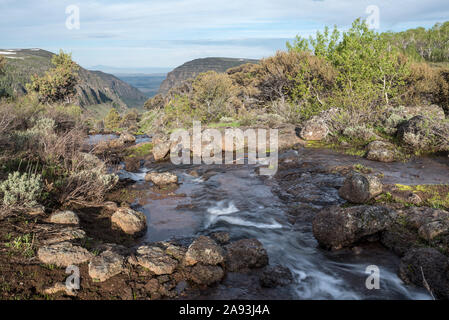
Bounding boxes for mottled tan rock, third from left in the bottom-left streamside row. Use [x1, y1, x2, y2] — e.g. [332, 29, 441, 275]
[131, 246, 178, 275]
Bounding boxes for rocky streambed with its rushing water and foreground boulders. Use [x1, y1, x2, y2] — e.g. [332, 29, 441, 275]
[4, 130, 449, 299]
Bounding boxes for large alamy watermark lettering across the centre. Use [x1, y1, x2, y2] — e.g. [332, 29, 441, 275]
[170, 121, 278, 176]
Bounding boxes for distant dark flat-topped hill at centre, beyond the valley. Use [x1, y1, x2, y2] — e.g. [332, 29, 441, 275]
[159, 58, 258, 94]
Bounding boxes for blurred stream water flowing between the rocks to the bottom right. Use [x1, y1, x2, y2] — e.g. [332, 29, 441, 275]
[95, 135, 449, 299]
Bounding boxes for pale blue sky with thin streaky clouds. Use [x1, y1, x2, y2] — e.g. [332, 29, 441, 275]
[0, 0, 449, 69]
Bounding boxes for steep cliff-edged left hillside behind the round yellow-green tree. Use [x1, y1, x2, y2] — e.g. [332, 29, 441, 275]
[0, 49, 146, 109]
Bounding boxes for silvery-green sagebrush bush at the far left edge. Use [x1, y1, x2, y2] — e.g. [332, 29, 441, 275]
[0, 171, 42, 207]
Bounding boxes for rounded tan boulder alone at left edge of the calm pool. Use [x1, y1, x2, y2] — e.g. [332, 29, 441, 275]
[111, 208, 147, 236]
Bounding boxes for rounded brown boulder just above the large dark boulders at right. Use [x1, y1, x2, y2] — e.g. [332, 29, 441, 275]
[338, 173, 382, 203]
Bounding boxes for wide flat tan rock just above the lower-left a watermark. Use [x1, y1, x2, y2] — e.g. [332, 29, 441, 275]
[37, 242, 93, 267]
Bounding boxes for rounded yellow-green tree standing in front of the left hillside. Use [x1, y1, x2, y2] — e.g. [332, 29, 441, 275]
[27, 50, 79, 103]
